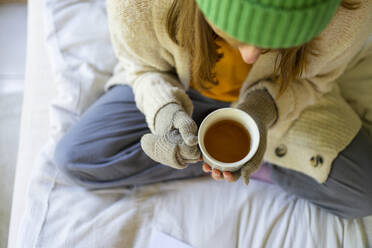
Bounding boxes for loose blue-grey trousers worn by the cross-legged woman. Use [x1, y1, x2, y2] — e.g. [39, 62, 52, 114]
[54, 85, 372, 217]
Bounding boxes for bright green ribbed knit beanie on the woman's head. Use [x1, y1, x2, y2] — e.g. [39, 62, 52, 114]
[196, 0, 341, 48]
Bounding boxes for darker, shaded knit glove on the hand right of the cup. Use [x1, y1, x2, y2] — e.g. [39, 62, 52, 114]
[236, 89, 277, 185]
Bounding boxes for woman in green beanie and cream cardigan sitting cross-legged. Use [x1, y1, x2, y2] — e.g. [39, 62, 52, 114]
[55, 0, 372, 218]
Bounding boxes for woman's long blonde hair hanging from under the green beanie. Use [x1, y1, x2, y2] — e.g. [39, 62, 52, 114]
[166, 0, 359, 97]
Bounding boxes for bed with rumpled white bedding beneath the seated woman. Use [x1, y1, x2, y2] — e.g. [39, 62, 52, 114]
[9, 0, 372, 248]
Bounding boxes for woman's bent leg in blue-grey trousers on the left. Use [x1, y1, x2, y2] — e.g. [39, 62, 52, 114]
[54, 85, 228, 188]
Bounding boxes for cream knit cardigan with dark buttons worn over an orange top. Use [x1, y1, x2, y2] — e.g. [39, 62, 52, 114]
[105, 0, 372, 183]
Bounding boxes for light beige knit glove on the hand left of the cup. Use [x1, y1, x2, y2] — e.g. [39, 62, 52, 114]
[141, 103, 200, 169]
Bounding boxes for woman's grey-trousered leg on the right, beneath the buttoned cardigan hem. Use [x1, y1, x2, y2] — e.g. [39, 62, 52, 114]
[270, 128, 372, 218]
